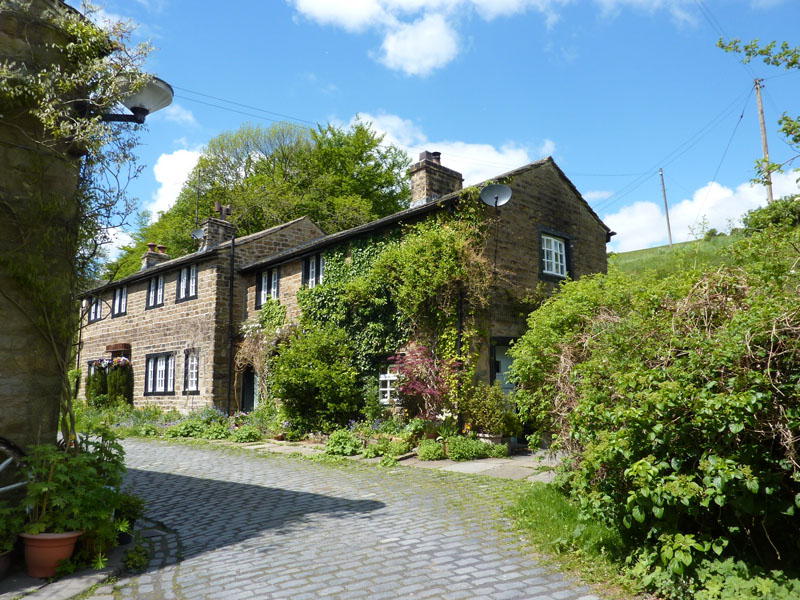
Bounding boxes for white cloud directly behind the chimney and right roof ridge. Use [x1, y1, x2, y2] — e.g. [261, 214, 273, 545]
[351, 113, 555, 186]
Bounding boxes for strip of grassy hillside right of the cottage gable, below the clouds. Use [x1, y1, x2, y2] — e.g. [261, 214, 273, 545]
[608, 234, 742, 275]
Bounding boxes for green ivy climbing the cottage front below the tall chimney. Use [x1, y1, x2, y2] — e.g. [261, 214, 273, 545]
[298, 188, 491, 374]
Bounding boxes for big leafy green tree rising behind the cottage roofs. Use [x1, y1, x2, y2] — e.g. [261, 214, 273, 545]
[108, 121, 410, 277]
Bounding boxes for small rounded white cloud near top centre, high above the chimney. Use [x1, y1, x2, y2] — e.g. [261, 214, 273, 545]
[380, 14, 458, 77]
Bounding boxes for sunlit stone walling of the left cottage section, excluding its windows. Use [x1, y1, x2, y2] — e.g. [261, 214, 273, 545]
[80, 218, 322, 412]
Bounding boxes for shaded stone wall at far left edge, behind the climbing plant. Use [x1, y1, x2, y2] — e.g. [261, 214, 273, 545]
[0, 0, 79, 454]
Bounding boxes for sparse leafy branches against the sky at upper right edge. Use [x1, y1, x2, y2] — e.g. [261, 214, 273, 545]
[717, 38, 800, 182]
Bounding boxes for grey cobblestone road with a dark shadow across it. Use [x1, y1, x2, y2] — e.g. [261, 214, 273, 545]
[87, 440, 597, 600]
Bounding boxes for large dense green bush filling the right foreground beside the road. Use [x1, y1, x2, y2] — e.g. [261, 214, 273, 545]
[512, 227, 800, 598]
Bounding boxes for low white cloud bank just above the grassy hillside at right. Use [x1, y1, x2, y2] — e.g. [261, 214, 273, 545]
[603, 173, 800, 252]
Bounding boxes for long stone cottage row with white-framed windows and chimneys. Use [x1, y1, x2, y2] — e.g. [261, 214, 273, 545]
[81, 152, 613, 411]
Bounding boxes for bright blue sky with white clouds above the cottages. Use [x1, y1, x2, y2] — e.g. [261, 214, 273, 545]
[81, 0, 800, 251]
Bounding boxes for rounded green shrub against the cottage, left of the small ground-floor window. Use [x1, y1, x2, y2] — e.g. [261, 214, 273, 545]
[271, 326, 362, 431]
